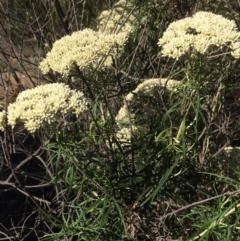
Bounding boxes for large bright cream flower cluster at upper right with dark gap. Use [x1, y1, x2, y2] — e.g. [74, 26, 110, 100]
[158, 12, 240, 59]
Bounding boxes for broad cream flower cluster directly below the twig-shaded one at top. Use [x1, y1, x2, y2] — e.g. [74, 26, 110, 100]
[39, 29, 127, 76]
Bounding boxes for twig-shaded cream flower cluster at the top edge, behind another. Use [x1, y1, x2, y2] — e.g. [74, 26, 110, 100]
[98, 0, 136, 33]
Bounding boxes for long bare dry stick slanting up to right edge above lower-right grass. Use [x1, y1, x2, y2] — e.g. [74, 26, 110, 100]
[159, 190, 240, 221]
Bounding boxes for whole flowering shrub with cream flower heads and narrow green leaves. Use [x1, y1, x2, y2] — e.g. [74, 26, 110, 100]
[0, 0, 240, 241]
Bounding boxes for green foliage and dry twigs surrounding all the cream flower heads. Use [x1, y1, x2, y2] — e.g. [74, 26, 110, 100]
[0, 0, 240, 241]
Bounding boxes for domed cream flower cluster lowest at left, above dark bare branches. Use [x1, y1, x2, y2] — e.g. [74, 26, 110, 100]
[7, 83, 87, 133]
